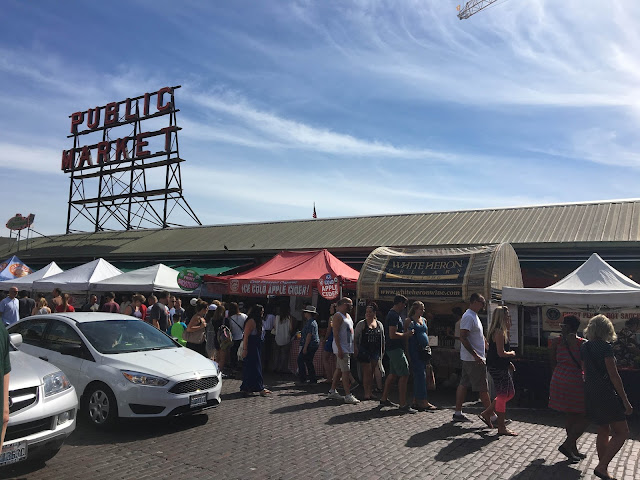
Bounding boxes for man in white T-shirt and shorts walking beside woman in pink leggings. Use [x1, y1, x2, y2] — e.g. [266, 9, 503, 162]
[453, 293, 491, 422]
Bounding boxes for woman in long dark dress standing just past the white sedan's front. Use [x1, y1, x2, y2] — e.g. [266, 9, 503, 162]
[240, 304, 271, 397]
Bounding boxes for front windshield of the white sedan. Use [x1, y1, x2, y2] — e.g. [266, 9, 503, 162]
[78, 320, 179, 354]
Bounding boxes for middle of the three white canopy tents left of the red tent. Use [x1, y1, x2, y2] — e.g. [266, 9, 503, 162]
[32, 258, 122, 292]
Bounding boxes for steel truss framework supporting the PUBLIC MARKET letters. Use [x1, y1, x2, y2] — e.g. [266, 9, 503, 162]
[66, 86, 202, 233]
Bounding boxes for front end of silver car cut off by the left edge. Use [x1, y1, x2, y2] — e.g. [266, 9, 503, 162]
[0, 334, 78, 468]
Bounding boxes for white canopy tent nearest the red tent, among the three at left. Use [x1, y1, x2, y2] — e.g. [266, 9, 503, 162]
[91, 263, 187, 293]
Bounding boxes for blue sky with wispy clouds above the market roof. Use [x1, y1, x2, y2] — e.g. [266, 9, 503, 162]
[0, 0, 640, 235]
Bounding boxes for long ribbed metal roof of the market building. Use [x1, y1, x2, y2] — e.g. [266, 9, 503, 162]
[0, 199, 640, 261]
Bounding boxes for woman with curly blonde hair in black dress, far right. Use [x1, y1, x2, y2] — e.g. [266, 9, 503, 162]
[580, 315, 633, 479]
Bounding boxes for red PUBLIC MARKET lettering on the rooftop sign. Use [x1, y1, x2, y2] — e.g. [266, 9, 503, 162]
[61, 87, 180, 172]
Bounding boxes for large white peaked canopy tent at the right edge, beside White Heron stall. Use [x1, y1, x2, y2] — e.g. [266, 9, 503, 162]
[502, 253, 640, 310]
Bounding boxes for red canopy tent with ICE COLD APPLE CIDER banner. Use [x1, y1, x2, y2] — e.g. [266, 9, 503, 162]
[203, 249, 360, 298]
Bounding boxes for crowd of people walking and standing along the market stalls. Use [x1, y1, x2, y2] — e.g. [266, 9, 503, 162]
[0, 287, 640, 479]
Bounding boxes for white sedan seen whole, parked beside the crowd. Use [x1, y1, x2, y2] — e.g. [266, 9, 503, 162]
[9, 312, 222, 427]
